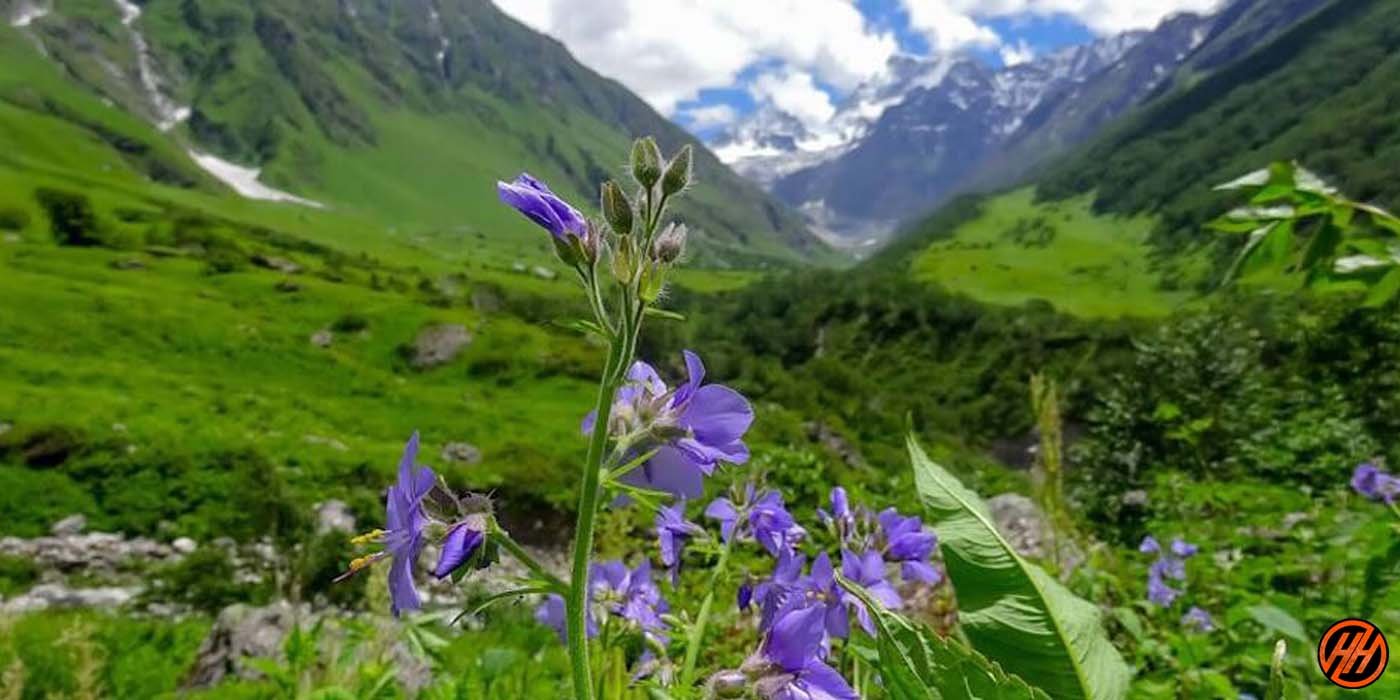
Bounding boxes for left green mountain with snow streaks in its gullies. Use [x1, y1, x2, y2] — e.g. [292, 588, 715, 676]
[0, 0, 830, 266]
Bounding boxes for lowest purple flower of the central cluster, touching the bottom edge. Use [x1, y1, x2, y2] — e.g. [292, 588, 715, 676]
[755, 608, 858, 700]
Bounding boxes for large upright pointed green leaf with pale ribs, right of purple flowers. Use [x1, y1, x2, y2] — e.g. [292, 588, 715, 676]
[909, 435, 1133, 700]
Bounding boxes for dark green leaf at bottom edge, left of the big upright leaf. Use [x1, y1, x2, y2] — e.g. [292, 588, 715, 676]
[840, 578, 1049, 700]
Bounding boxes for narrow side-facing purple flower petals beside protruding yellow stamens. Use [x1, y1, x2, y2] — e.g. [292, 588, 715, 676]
[384, 431, 437, 617]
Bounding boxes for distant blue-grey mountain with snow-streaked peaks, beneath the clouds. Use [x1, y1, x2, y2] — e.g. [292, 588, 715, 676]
[720, 0, 1323, 246]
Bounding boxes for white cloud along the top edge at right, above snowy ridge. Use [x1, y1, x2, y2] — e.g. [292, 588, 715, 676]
[902, 0, 1224, 50]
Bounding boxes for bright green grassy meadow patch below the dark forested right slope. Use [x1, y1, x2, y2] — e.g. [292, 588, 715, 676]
[913, 189, 1189, 318]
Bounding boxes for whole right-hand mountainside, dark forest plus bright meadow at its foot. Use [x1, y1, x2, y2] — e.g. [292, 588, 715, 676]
[869, 0, 1400, 316]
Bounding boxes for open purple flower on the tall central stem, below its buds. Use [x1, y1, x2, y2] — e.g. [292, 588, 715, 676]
[604, 350, 753, 498]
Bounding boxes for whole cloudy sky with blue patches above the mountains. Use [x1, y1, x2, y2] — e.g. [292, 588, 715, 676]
[494, 0, 1222, 136]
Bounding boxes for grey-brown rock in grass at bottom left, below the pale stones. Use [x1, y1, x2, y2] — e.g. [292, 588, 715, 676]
[183, 601, 314, 689]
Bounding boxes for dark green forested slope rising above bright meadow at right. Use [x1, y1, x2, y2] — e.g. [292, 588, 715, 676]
[1039, 0, 1400, 259]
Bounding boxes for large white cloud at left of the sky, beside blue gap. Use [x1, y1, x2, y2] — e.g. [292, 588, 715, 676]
[496, 0, 897, 113]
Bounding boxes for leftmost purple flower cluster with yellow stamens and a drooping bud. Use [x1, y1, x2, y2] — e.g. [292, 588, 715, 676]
[340, 433, 493, 616]
